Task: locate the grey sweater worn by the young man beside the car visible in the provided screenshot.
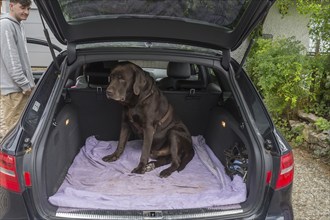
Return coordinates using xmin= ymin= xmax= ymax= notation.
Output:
xmin=0 ymin=15 xmax=35 ymax=95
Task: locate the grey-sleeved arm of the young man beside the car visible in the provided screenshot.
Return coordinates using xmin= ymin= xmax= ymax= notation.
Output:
xmin=1 ymin=22 xmax=31 ymax=91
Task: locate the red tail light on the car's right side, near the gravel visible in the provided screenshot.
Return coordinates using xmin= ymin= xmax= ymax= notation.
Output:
xmin=275 ymin=151 xmax=294 ymax=189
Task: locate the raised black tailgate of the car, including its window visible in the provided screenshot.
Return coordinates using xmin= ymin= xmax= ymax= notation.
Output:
xmin=35 ymin=0 xmax=275 ymax=50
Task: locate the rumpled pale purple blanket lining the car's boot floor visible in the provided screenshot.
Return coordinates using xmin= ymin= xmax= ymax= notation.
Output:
xmin=49 ymin=136 xmax=246 ymax=210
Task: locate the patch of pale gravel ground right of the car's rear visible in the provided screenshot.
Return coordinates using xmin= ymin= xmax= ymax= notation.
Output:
xmin=293 ymin=149 xmax=330 ymax=220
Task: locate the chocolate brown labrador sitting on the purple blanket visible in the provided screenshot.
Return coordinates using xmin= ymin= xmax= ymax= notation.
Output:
xmin=103 ymin=62 xmax=195 ymax=177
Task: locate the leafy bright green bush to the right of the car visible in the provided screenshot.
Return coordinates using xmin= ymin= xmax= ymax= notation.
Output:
xmin=246 ymin=38 xmax=313 ymax=121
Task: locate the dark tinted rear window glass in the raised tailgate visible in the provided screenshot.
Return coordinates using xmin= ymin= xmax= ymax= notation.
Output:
xmin=58 ymin=0 xmax=250 ymax=28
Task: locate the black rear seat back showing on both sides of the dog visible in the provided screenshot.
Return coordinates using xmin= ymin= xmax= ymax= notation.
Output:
xmin=65 ymin=85 xmax=221 ymax=140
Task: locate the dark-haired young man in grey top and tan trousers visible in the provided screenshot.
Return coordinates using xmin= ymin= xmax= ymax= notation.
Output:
xmin=0 ymin=0 xmax=35 ymax=138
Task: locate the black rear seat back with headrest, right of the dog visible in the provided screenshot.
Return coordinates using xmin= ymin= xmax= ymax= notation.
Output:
xmin=158 ymin=62 xmax=222 ymax=135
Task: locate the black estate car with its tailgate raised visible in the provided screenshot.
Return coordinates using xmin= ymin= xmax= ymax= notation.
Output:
xmin=0 ymin=0 xmax=294 ymax=219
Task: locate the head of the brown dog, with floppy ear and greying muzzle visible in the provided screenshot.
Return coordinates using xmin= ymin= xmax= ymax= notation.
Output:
xmin=106 ymin=62 xmax=147 ymax=102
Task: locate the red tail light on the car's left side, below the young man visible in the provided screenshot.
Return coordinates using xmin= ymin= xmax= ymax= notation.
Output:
xmin=0 ymin=152 xmax=20 ymax=192
